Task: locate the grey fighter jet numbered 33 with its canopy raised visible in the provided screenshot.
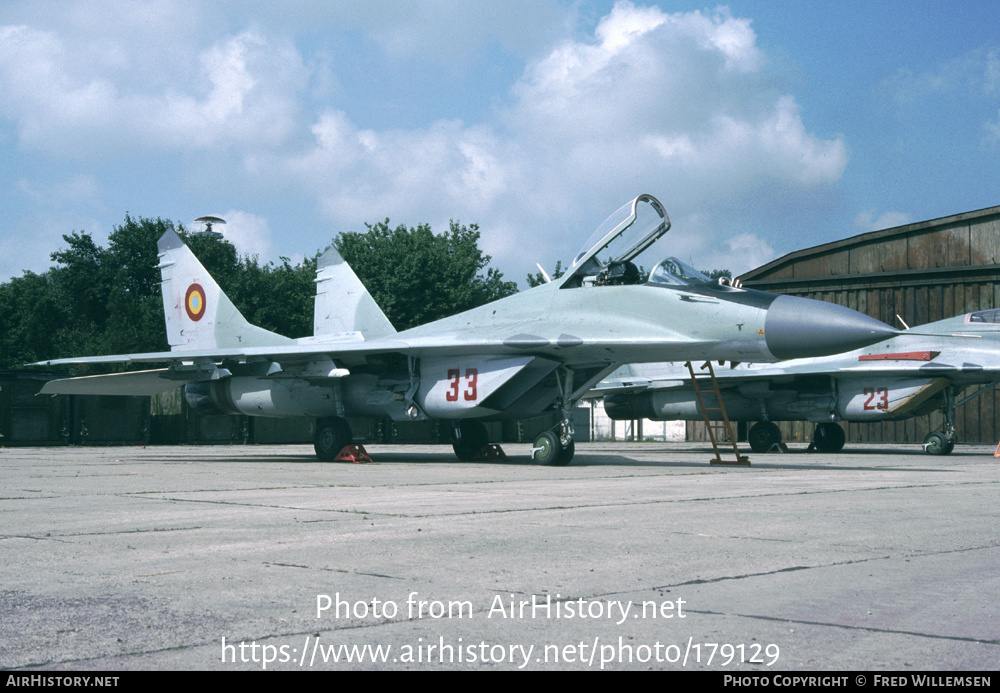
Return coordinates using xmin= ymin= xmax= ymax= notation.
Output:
xmin=35 ymin=195 xmax=897 ymax=465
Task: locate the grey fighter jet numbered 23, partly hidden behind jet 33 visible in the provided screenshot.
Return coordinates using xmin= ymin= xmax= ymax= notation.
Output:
xmin=591 ymin=310 xmax=1000 ymax=455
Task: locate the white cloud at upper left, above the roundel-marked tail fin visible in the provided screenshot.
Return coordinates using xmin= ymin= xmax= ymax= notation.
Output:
xmin=0 ymin=26 xmax=307 ymax=158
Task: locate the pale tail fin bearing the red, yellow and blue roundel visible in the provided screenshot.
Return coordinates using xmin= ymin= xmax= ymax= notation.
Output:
xmin=157 ymin=229 xmax=293 ymax=351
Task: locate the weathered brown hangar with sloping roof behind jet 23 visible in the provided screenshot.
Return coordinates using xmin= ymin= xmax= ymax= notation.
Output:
xmin=732 ymin=207 xmax=1000 ymax=444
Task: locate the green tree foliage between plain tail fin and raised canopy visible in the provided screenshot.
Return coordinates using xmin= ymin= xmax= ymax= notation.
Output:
xmin=334 ymin=219 xmax=517 ymax=330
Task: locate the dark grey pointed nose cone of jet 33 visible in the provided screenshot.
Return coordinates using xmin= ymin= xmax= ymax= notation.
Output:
xmin=764 ymin=295 xmax=899 ymax=359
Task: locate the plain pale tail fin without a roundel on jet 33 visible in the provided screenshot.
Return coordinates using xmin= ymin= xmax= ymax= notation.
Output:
xmin=313 ymin=246 xmax=396 ymax=339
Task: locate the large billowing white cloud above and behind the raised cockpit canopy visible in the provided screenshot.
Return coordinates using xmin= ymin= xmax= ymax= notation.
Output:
xmin=270 ymin=2 xmax=847 ymax=274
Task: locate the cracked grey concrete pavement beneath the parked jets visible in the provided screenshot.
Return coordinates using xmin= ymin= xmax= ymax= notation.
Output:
xmin=0 ymin=443 xmax=1000 ymax=672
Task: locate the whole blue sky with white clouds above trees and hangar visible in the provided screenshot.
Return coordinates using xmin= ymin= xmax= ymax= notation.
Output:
xmin=0 ymin=0 xmax=1000 ymax=283
